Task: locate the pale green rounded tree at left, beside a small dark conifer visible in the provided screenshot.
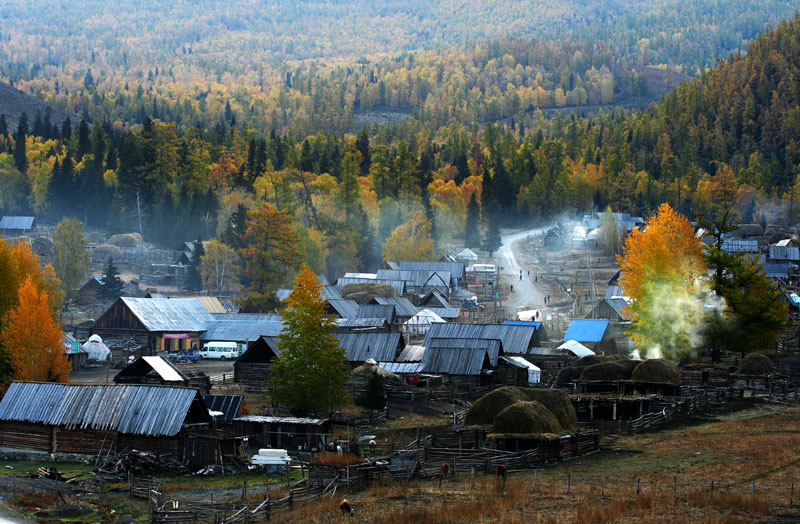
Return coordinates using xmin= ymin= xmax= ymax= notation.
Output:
xmin=53 ymin=218 xmax=92 ymax=298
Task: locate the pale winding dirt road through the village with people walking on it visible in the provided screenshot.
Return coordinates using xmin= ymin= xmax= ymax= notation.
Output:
xmin=495 ymin=228 xmax=546 ymax=315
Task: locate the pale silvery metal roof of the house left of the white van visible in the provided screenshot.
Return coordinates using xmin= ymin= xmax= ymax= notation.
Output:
xmin=120 ymin=297 xmax=213 ymax=332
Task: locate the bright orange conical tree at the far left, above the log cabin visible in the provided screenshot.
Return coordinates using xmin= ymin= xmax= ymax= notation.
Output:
xmin=2 ymin=277 xmax=70 ymax=382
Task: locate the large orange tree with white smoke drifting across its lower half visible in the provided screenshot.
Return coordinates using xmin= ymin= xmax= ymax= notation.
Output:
xmin=617 ymin=204 xmax=709 ymax=358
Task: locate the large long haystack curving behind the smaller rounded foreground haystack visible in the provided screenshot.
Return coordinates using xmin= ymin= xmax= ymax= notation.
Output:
xmin=464 ymin=386 xmax=578 ymax=433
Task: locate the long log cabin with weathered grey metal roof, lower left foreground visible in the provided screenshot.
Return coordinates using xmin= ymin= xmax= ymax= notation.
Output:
xmin=0 ymin=382 xmax=216 ymax=467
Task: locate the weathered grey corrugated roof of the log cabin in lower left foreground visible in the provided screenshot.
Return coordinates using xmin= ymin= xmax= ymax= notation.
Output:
xmin=0 ymin=382 xmax=210 ymax=436
